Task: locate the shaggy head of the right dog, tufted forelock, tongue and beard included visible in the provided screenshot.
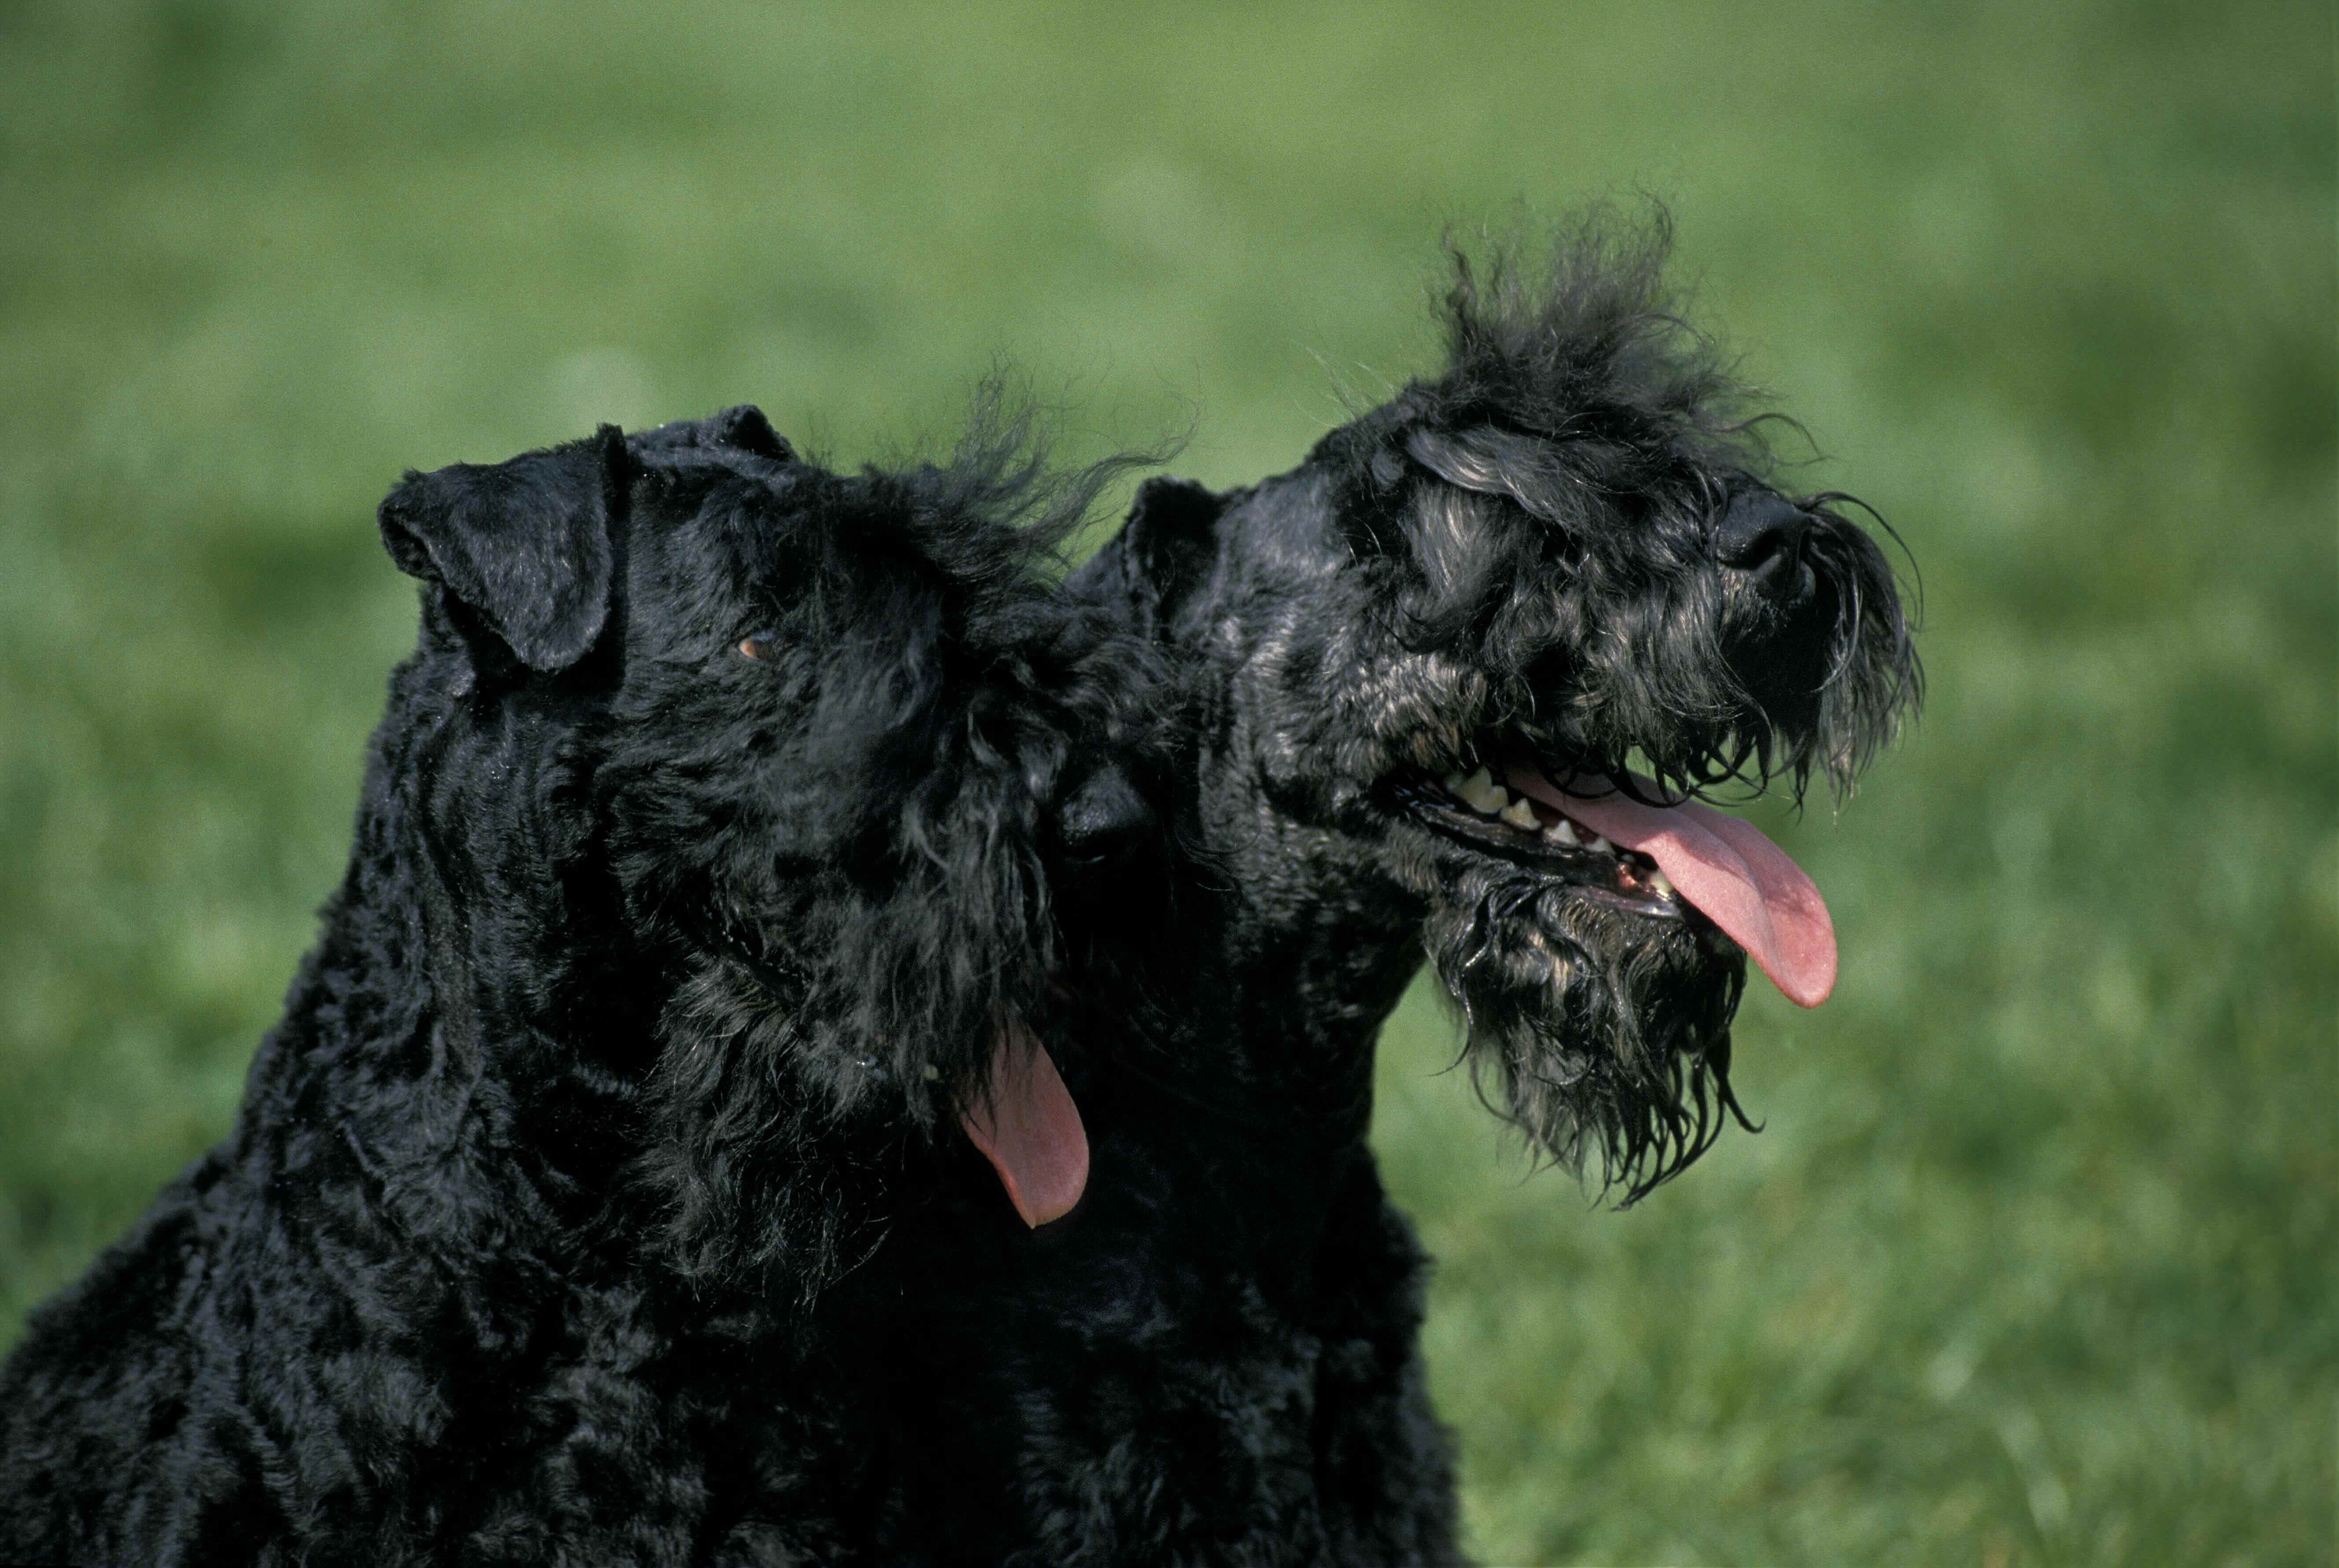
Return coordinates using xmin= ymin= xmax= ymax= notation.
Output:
xmin=1078 ymin=225 xmax=1920 ymax=1196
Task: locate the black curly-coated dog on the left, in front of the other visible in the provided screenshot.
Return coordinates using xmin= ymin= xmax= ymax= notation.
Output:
xmin=0 ymin=410 xmax=1170 ymax=1563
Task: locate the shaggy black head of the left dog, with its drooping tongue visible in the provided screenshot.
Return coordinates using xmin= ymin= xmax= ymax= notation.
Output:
xmin=381 ymin=410 xmax=1153 ymax=1280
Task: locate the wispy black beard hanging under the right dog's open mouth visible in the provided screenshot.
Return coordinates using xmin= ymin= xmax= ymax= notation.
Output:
xmin=1427 ymin=866 xmax=1747 ymax=1208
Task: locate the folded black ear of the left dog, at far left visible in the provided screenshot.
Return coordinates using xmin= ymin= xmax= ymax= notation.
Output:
xmin=381 ymin=426 xmax=627 ymax=672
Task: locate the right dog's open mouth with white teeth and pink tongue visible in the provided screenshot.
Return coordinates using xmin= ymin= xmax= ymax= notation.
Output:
xmin=1394 ymin=749 xmax=1836 ymax=1006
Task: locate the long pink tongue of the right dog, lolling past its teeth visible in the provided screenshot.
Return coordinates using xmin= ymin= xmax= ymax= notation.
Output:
xmin=1504 ymin=768 xmax=1836 ymax=1006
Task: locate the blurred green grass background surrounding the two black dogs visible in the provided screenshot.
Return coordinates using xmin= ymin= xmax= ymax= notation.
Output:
xmin=0 ymin=0 xmax=2339 ymax=1566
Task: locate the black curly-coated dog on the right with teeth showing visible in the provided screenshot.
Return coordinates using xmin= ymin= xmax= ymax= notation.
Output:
xmin=1024 ymin=222 xmax=1920 ymax=1563
